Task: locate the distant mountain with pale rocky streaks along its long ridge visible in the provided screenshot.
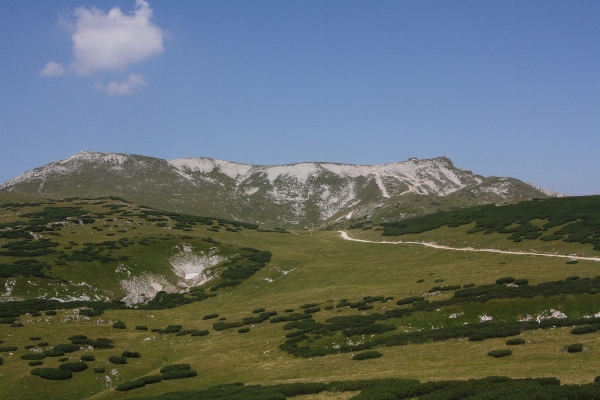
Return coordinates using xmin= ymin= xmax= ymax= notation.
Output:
xmin=0 ymin=151 xmax=552 ymax=228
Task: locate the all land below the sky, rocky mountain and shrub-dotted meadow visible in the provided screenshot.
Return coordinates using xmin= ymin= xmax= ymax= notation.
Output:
xmin=0 ymin=152 xmax=600 ymax=400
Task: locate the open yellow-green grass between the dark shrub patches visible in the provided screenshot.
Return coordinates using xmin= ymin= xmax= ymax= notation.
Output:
xmin=0 ymin=193 xmax=600 ymax=399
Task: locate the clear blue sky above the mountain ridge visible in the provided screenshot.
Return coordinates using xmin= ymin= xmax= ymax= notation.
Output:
xmin=0 ymin=0 xmax=600 ymax=195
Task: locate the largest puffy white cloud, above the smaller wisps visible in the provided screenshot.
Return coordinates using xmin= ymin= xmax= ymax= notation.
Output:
xmin=72 ymin=0 xmax=164 ymax=74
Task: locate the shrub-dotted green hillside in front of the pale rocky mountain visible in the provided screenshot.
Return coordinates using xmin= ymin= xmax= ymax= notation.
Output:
xmin=0 ymin=193 xmax=600 ymax=400
